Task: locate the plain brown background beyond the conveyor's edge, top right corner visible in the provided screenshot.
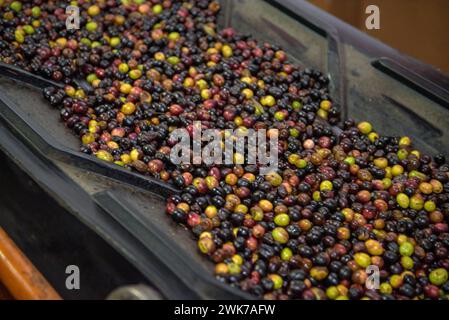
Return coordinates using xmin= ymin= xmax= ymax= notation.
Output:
xmin=308 ymin=0 xmax=449 ymax=74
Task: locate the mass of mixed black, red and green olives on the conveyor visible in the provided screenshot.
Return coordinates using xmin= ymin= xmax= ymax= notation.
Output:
xmin=5 ymin=0 xmax=449 ymax=300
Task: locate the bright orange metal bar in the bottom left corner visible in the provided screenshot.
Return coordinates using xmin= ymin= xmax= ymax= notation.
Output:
xmin=0 ymin=228 xmax=61 ymax=300
